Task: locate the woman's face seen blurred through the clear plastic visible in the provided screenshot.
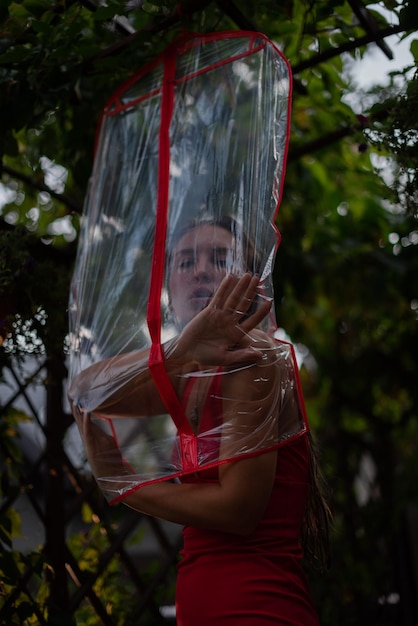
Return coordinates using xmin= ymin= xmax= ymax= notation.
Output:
xmin=168 ymin=225 xmax=237 ymax=326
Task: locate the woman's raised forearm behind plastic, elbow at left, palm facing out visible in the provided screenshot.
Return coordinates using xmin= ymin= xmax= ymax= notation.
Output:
xmin=68 ymin=274 xmax=271 ymax=417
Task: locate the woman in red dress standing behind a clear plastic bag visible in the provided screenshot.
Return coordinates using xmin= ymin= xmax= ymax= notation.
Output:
xmin=69 ymin=217 xmax=328 ymax=626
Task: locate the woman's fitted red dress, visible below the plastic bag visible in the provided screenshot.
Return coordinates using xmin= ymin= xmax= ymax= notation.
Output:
xmin=176 ymin=372 xmax=319 ymax=626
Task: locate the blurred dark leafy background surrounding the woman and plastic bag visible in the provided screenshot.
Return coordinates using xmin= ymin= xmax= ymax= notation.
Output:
xmin=0 ymin=0 xmax=418 ymax=626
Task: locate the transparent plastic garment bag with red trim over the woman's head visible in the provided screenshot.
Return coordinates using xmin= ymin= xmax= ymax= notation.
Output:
xmin=69 ymin=31 xmax=307 ymax=502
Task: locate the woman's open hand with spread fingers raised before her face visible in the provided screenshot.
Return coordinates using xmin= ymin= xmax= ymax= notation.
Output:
xmin=171 ymin=274 xmax=271 ymax=366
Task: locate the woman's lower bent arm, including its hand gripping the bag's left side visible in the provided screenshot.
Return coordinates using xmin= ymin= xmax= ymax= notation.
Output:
xmin=80 ymin=344 xmax=278 ymax=535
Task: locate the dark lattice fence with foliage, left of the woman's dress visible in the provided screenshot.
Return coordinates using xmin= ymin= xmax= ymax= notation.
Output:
xmin=0 ymin=356 xmax=181 ymax=626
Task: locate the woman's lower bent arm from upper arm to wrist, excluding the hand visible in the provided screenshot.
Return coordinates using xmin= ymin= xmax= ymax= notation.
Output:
xmin=124 ymin=354 xmax=280 ymax=535
